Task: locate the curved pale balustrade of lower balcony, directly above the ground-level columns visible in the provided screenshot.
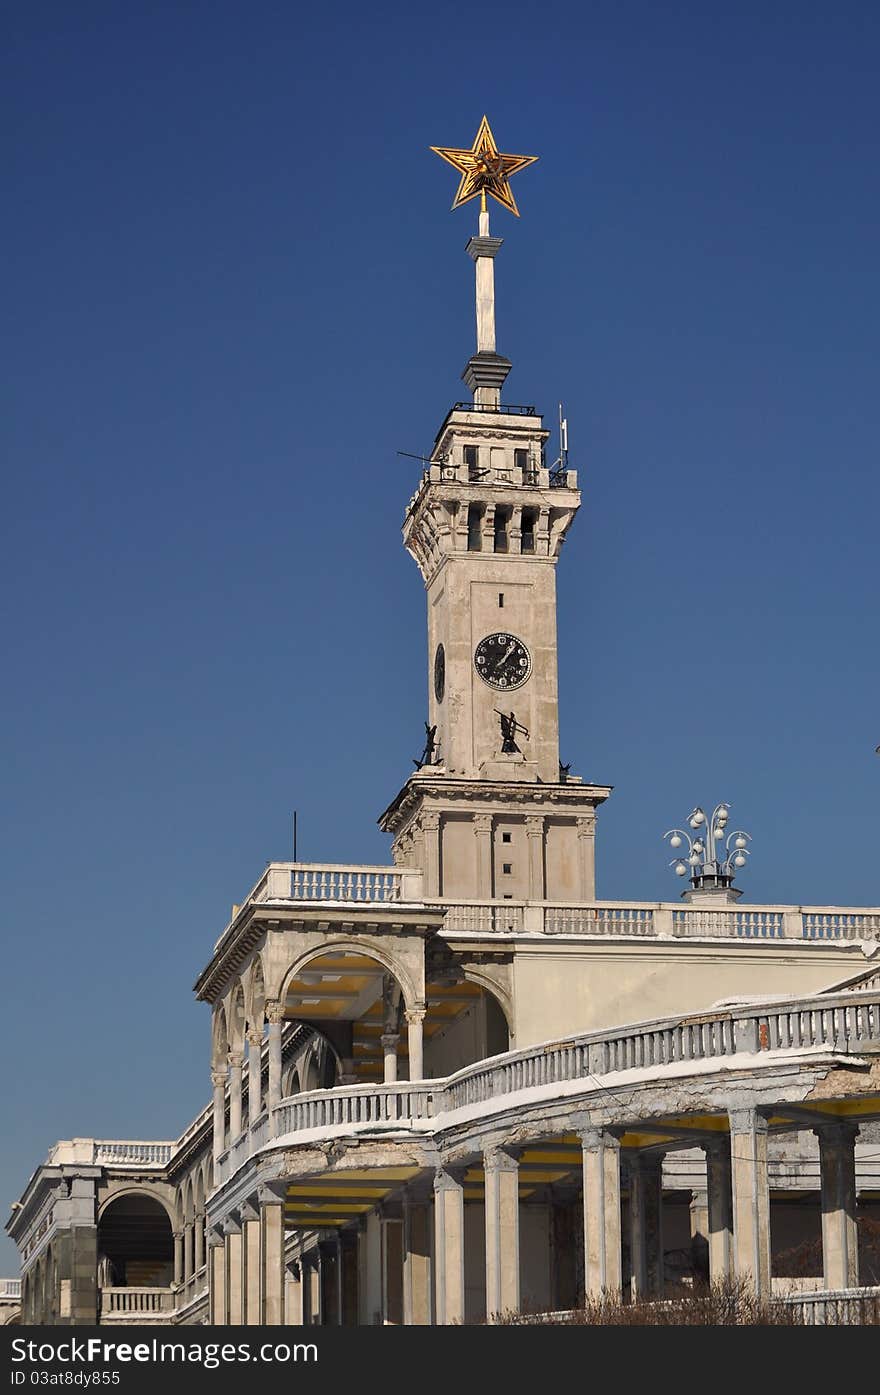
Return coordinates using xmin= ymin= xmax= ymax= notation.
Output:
xmin=218 ymin=992 xmax=880 ymax=1183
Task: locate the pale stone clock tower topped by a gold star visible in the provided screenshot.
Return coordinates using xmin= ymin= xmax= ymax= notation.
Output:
xmin=379 ymin=117 xmax=609 ymax=910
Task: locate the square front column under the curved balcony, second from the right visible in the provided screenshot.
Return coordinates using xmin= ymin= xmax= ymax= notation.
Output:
xmin=729 ymin=1109 xmax=770 ymax=1297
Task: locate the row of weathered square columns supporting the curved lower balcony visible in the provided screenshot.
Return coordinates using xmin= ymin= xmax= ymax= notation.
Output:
xmin=209 ymin=1108 xmax=858 ymax=1325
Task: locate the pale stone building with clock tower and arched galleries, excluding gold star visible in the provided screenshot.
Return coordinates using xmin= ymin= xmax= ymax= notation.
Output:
xmin=7 ymin=133 xmax=880 ymax=1324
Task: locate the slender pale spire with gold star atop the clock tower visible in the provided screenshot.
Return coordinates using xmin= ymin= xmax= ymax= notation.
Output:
xmin=431 ymin=116 xmax=537 ymax=409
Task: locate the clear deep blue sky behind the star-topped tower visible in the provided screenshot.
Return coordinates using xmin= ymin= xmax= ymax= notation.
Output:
xmin=0 ymin=0 xmax=880 ymax=1272
